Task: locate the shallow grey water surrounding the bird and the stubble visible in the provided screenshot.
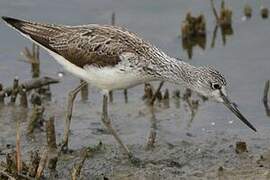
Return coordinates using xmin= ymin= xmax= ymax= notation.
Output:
xmin=0 ymin=0 xmax=270 ymax=177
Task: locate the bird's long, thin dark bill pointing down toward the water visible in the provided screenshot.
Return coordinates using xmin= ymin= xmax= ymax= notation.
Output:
xmin=220 ymin=91 xmax=257 ymax=132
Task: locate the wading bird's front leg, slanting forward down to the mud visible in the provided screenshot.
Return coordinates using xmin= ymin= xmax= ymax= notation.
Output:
xmin=101 ymin=94 xmax=132 ymax=158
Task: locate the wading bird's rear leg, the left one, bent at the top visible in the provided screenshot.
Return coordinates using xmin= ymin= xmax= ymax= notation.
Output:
xmin=61 ymin=81 xmax=87 ymax=152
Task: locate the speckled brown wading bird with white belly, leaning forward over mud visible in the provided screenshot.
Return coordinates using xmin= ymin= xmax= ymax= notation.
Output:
xmin=2 ymin=17 xmax=256 ymax=157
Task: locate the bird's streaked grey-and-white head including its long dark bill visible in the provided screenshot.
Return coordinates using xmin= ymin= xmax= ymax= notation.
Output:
xmin=192 ymin=66 xmax=256 ymax=131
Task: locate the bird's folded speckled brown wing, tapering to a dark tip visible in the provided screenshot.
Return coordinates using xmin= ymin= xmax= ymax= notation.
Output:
xmin=3 ymin=17 xmax=147 ymax=67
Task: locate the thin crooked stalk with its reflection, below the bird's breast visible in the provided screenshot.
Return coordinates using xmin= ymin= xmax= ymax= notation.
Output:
xmin=146 ymin=81 xmax=164 ymax=150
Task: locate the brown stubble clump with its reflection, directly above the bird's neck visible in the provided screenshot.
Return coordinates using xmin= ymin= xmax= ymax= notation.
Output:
xmin=181 ymin=12 xmax=206 ymax=59
